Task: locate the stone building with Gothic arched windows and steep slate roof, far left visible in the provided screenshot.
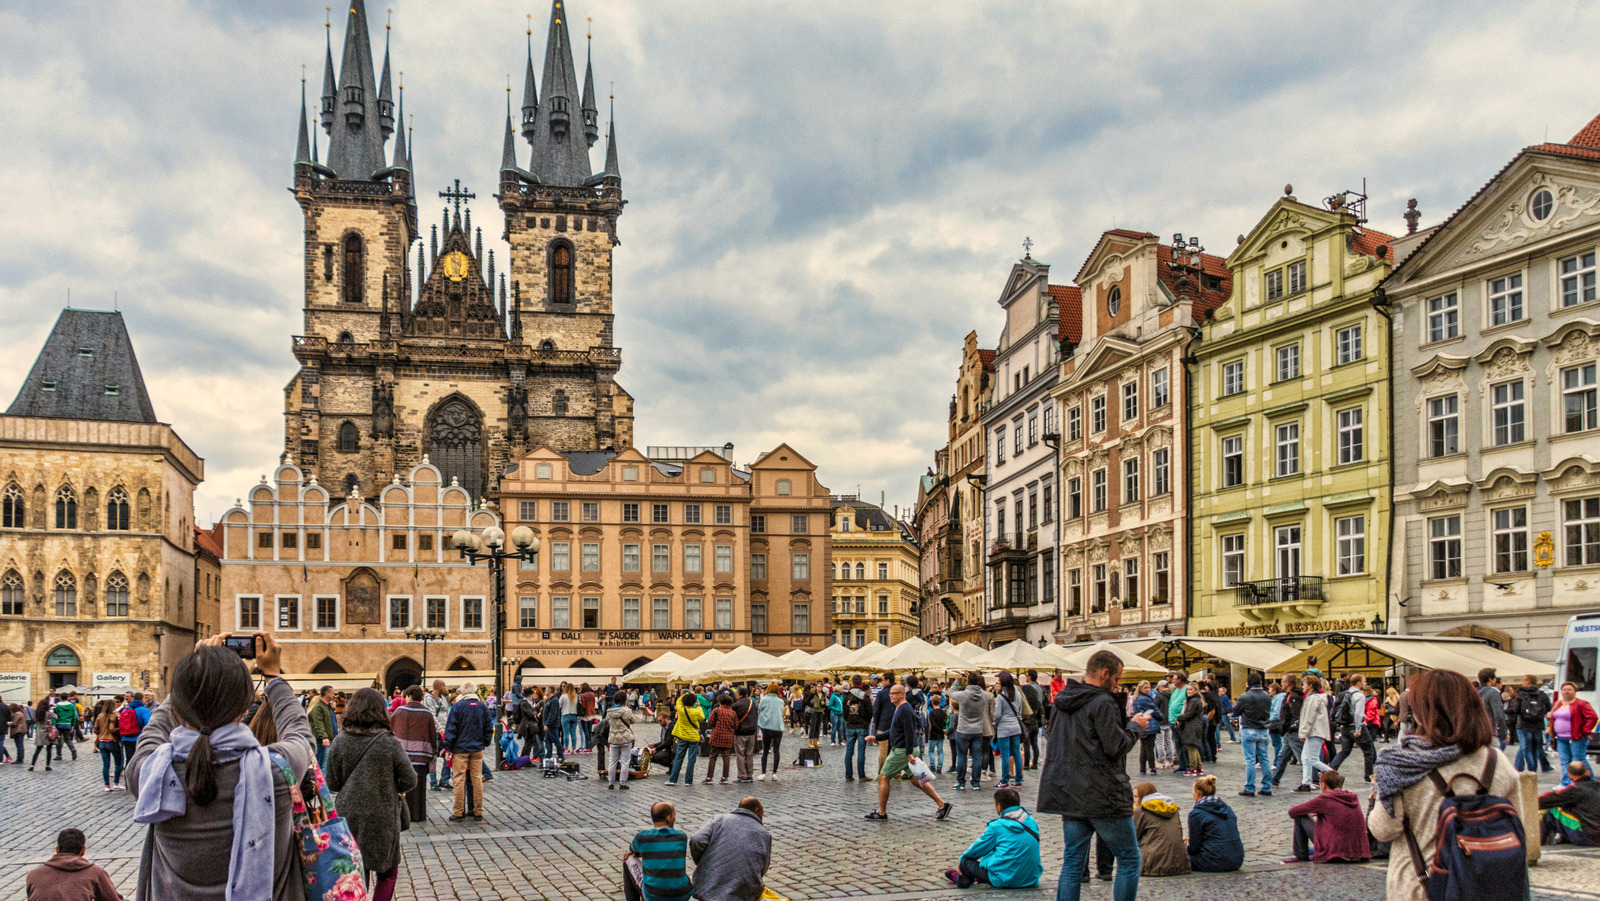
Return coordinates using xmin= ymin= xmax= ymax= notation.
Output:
xmin=0 ymin=309 xmax=206 ymax=703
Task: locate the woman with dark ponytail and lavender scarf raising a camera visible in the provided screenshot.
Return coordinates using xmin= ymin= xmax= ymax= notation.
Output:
xmin=128 ymin=632 xmax=314 ymax=901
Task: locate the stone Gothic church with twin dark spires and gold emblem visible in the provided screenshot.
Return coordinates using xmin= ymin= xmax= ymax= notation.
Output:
xmin=285 ymin=0 xmax=634 ymax=499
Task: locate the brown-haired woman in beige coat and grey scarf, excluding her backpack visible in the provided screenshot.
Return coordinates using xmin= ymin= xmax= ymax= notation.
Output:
xmin=1366 ymin=669 xmax=1522 ymax=901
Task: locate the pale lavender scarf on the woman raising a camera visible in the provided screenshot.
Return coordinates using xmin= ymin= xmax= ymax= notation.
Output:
xmin=133 ymin=723 xmax=277 ymax=901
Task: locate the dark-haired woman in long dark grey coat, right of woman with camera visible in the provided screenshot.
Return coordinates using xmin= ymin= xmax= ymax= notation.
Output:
xmin=328 ymin=688 xmax=416 ymax=901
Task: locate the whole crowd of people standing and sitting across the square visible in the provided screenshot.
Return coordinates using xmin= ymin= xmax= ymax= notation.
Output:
xmin=6 ymin=634 xmax=1600 ymax=901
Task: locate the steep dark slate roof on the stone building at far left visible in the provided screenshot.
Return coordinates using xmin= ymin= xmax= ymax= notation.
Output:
xmin=6 ymin=309 xmax=157 ymax=422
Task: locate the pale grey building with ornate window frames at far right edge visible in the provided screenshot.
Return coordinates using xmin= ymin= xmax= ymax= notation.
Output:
xmin=1384 ymin=118 xmax=1600 ymax=659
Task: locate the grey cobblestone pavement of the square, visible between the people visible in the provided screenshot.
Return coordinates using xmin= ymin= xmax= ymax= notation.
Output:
xmin=0 ymin=735 xmax=1600 ymax=901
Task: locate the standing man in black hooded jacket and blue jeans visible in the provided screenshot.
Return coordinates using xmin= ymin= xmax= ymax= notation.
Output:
xmin=1037 ymin=650 xmax=1150 ymax=901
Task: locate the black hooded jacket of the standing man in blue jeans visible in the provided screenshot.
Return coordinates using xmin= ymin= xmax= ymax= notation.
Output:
xmin=1037 ymin=682 xmax=1144 ymax=819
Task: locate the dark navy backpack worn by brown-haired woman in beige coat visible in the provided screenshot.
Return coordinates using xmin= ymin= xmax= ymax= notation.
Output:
xmin=1405 ymin=749 xmax=1528 ymax=901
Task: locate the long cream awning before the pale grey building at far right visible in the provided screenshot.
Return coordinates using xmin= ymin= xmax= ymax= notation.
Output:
xmin=1272 ymin=632 xmax=1555 ymax=679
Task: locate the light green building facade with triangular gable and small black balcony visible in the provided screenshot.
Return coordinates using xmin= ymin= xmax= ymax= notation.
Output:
xmin=1187 ymin=194 xmax=1394 ymax=639
